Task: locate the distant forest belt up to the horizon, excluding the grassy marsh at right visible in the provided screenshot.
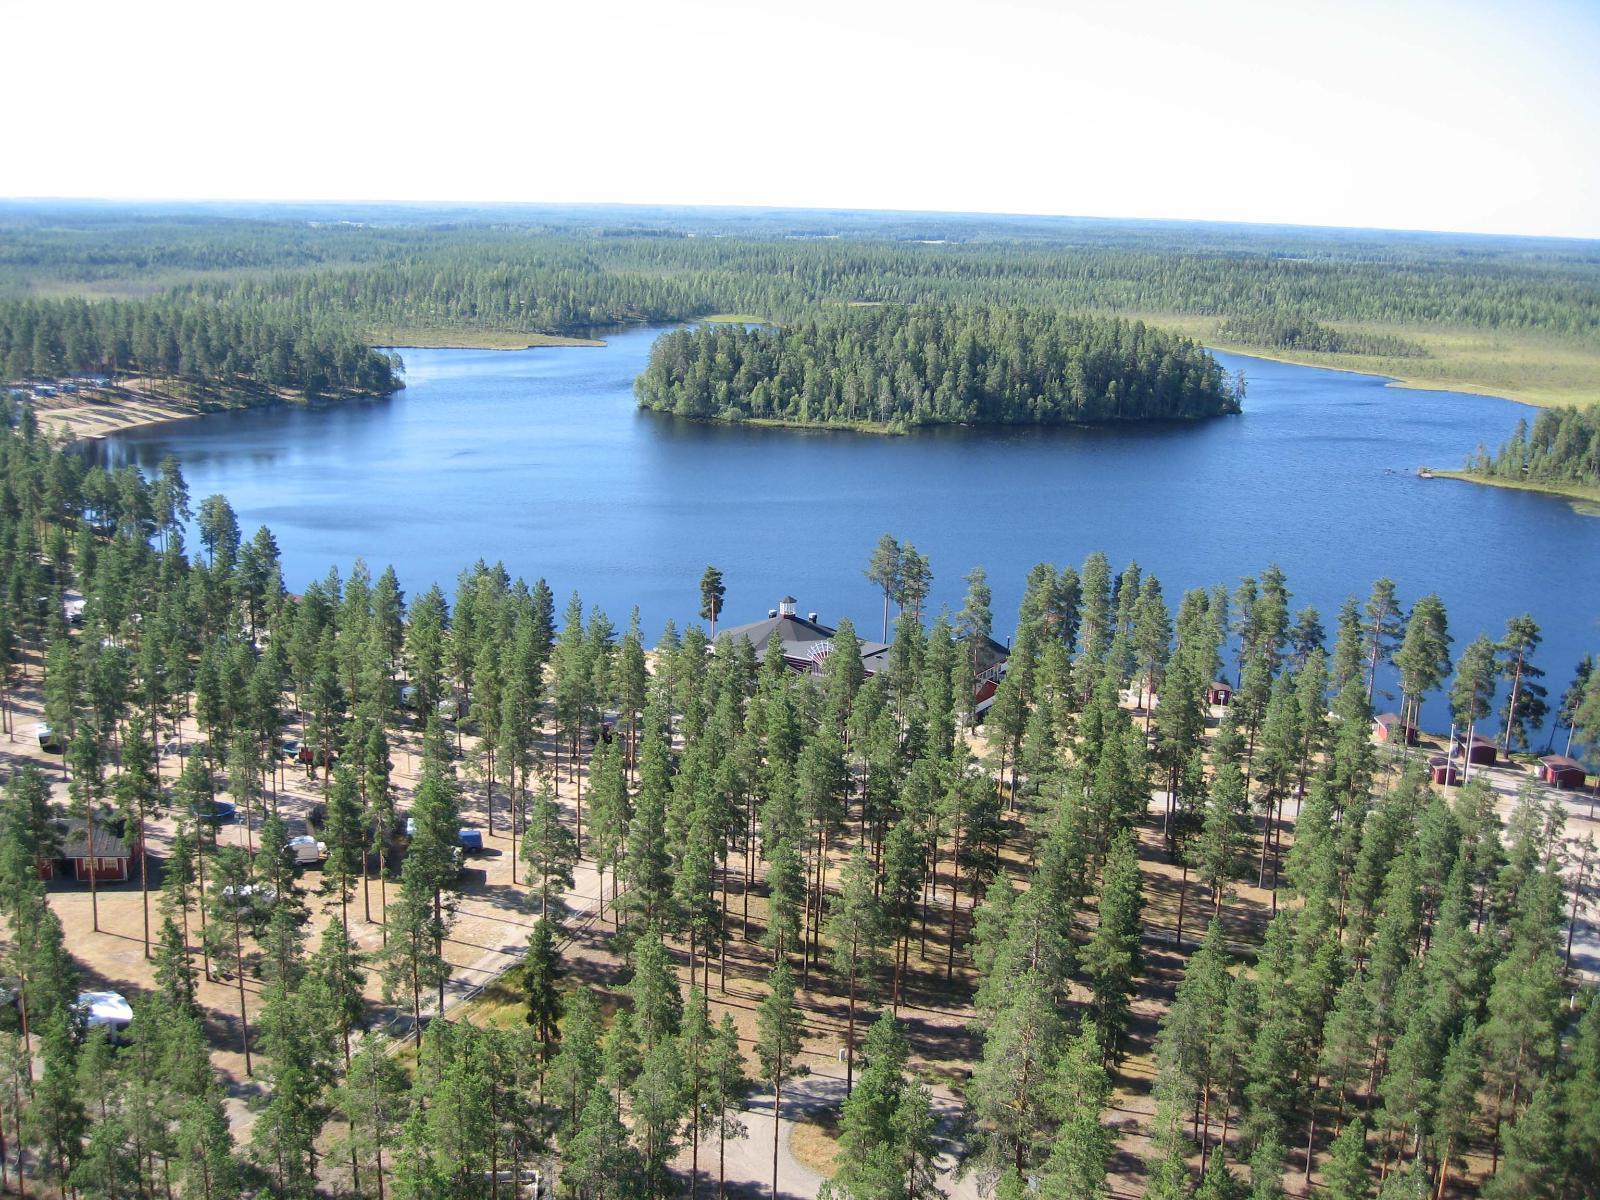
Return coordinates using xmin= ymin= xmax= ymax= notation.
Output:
xmin=12 ymin=210 xmax=1600 ymax=336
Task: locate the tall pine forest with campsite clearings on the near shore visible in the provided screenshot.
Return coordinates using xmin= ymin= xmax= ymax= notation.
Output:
xmin=0 ymin=390 xmax=1600 ymax=1200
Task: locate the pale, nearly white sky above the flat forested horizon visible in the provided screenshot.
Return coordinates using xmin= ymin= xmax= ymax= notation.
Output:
xmin=0 ymin=0 xmax=1600 ymax=237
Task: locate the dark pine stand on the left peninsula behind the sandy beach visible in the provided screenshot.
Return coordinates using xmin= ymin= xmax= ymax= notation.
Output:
xmin=0 ymin=299 xmax=400 ymax=397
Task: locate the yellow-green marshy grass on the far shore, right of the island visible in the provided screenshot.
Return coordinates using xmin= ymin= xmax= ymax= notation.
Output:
xmin=1122 ymin=312 xmax=1600 ymax=408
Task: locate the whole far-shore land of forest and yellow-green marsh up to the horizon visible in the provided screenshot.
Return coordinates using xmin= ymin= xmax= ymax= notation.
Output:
xmin=9 ymin=203 xmax=1600 ymax=403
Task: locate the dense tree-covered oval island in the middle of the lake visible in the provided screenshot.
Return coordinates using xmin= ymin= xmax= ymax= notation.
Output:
xmin=634 ymin=306 xmax=1238 ymax=429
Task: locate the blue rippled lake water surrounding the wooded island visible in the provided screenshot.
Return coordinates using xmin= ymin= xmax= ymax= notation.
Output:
xmin=98 ymin=330 xmax=1600 ymax=739
